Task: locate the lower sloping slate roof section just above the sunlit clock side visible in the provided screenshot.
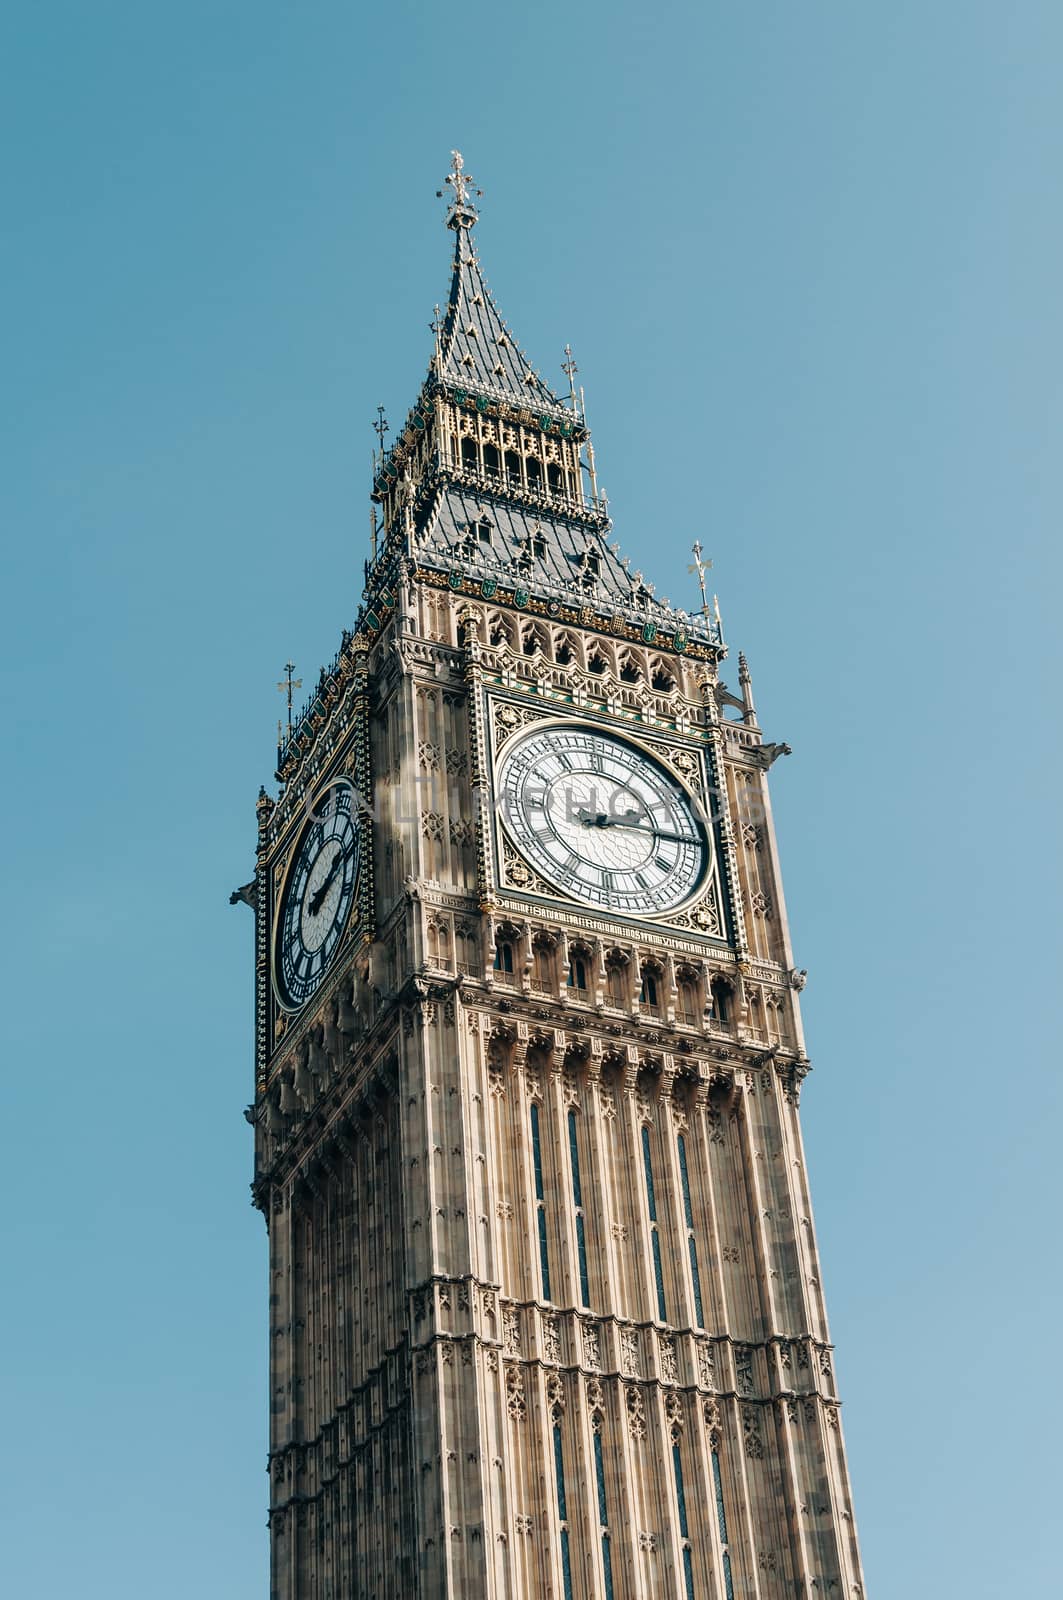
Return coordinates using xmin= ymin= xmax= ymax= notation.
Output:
xmin=413 ymin=483 xmax=685 ymax=632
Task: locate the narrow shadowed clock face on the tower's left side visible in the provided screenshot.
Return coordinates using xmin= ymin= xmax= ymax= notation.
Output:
xmin=274 ymin=781 xmax=359 ymax=1011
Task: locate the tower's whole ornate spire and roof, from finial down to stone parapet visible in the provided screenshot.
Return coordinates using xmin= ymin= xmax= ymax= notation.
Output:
xmin=359 ymin=150 xmax=719 ymax=651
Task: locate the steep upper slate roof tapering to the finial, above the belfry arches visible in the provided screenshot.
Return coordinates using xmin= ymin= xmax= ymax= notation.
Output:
xmin=439 ymin=227 xmax=568 ymax=414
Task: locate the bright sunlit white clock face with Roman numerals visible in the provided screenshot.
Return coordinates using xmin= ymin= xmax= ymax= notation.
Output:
xmin=498 ymin=725 xmax=709 ymax=917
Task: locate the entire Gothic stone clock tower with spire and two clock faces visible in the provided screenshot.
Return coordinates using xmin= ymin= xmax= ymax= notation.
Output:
xmin=249 ymin=157 xmax=863 ymax=1600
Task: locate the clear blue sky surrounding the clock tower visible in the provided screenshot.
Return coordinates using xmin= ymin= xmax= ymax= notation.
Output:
xmin=0 ymin=0 xmax=1063 ymax=1600
